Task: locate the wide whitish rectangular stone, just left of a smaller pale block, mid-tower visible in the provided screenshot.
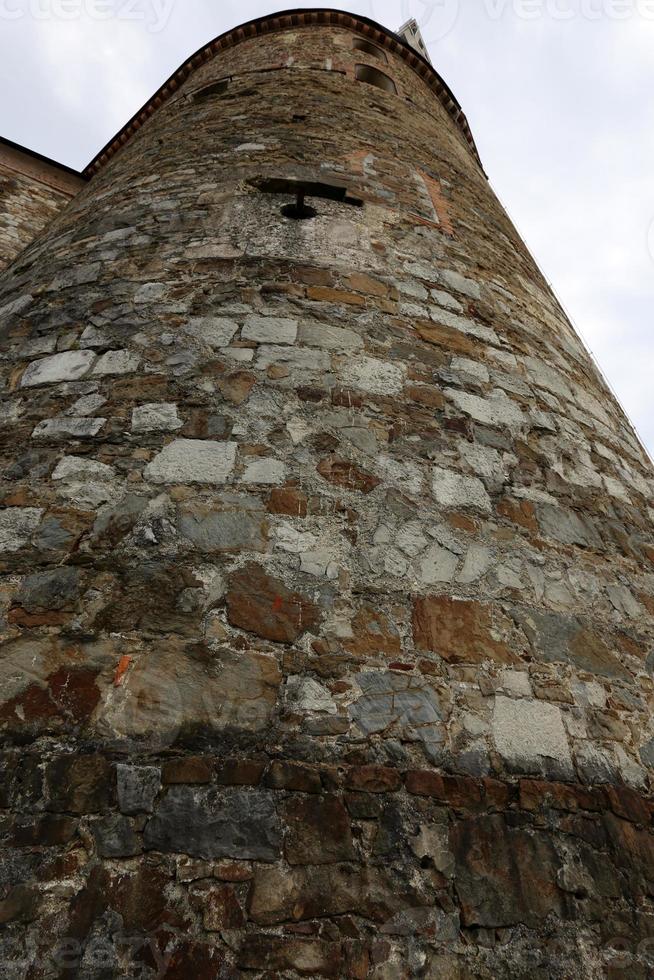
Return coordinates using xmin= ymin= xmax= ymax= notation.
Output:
xmin=145 ymin=439 xmax=236 ymax=484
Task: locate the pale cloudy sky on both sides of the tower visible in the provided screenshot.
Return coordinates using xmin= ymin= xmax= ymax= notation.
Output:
xmin=0 ymin=0 xmax=654 ymax=455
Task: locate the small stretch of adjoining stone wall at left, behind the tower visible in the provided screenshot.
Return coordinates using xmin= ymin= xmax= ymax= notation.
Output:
xmin=0 ymin=140 xmax=84 ymax=269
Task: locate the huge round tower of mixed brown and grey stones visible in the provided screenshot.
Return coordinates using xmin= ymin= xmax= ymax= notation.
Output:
xmin=0 ymin=10 xmax=654 ymax=980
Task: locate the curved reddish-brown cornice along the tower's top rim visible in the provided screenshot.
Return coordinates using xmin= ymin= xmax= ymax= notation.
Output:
xmin=83 ymin=8 xmax=483 ymax=179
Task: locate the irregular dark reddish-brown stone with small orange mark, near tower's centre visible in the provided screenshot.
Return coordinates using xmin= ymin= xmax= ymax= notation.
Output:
xmin=227 ymin=564 xmax=321 ymax=643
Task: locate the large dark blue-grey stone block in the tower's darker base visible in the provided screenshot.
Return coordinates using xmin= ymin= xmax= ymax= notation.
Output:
xmin=144 ymin=786 xmax=282 ymax=861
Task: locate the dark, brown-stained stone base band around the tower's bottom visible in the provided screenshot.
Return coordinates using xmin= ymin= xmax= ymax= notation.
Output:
xmin=0 ymin=752 xmax=654 ymax=980
